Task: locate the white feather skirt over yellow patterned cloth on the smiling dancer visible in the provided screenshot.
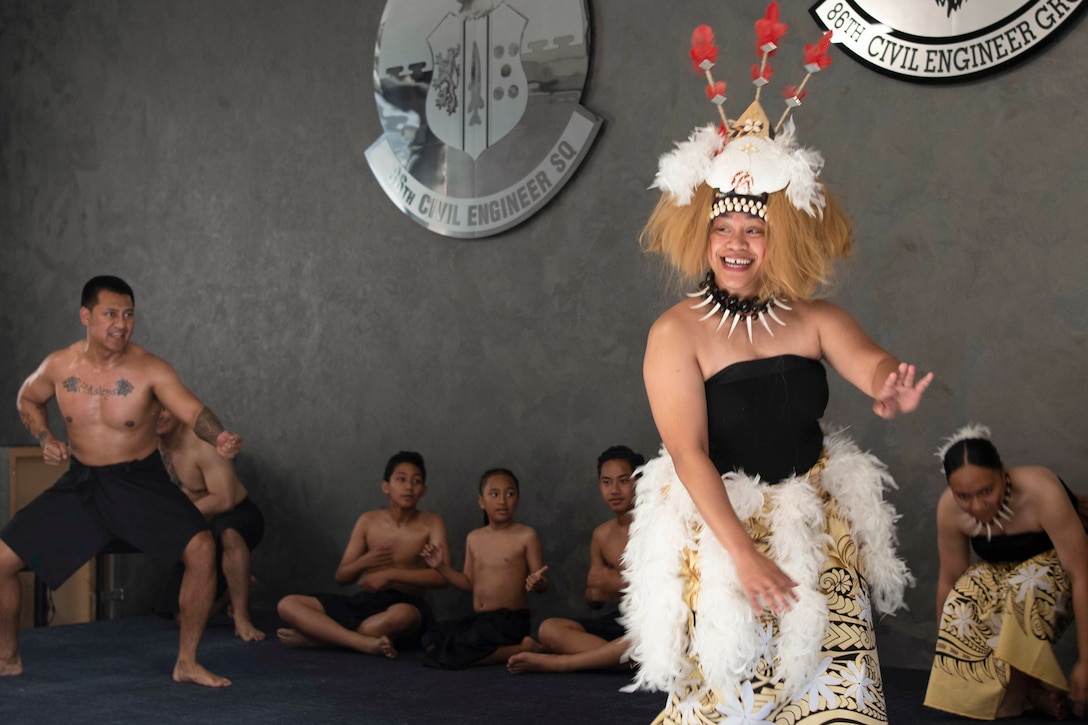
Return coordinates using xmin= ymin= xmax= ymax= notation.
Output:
xmin=620 ymin=431 xmax=914 ymax=723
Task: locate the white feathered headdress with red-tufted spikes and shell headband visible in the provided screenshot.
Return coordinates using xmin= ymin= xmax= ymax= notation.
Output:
xmin=652 ymin=2 xmax=831 ymax=219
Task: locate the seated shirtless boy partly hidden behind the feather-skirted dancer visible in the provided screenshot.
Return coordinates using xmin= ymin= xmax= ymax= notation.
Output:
xmin=506 ymin=445 xmax=645 ymax=675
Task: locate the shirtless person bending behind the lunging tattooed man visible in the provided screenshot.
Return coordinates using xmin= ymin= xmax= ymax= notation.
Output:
xmin=156 ymin=409 xmax=264 ymax=642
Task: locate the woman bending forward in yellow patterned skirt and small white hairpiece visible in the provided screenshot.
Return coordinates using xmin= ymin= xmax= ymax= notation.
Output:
xmin=926 ymin=425 xmax=1088 ymax=720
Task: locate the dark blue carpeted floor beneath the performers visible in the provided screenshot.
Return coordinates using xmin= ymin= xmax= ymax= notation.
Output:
xmin=0 ymin=614 xmax=1070 ymax=725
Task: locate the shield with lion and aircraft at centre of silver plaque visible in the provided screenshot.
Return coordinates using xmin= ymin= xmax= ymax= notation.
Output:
xmin=426 ymin=3 xmax=529 ymax=160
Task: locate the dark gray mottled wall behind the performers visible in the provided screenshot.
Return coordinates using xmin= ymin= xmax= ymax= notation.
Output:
xmin=0 ymin=0 xmax=1088 ymax=666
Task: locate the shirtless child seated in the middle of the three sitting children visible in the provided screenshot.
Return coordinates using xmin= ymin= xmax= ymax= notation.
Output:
xmin=423 ymin=468 xmax=547 ymax=669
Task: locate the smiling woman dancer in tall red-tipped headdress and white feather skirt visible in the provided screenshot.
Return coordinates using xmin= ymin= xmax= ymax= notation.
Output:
xmin=622 ymin=3 xmax=932 ymax=724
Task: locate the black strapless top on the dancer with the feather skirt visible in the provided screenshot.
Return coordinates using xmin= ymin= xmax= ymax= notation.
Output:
xmin=704 ymin=355 xmax=828 ymax=483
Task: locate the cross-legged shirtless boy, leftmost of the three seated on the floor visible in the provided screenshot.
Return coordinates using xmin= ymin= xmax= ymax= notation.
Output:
xmin=276 ymin=451 xmax=446 ymax=659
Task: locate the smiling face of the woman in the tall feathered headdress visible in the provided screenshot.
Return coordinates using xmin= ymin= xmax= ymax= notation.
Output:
xmin=706 ymin=211 xmax=767 ymax=297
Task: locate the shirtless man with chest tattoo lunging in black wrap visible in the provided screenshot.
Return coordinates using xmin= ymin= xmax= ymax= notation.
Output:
xmin=0 ymin=277 xmax=242 ymax=687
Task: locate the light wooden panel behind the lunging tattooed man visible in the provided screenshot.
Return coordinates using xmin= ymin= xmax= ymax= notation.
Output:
xmin=8 ymin=446 xmax=95 ymax=628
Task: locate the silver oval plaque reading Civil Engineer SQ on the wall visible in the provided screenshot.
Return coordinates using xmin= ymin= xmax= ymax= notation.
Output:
xmin=367 ymin=0 xmax=601 ymax=238
